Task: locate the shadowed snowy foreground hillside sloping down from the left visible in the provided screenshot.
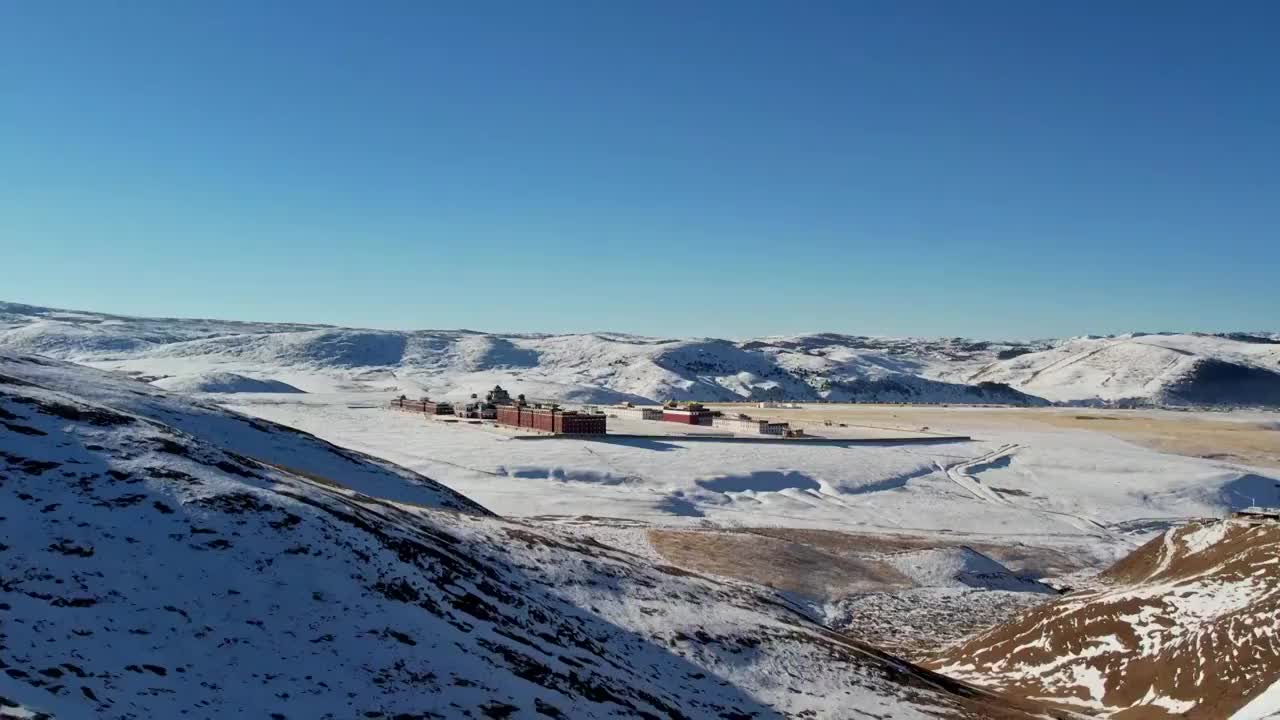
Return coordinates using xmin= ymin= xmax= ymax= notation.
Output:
xmin=0 ymin=354 xmax=1062 ymax=719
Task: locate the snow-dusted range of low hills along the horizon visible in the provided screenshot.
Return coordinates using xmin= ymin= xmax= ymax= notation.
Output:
xmin=0 ymin=302 xmax=1280 ymax=407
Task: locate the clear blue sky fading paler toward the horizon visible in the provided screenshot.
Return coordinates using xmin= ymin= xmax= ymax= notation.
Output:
xmin=0 ymin=0 xmax=1280 ymax=337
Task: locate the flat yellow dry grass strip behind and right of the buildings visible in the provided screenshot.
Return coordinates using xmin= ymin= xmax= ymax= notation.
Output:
xmin=710 ymin=404 xmax=1280 ymax=468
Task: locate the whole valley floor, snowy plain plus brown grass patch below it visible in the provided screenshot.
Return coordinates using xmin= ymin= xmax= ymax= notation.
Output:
xmin=223 ymin=393 xmax=1280 ymax=657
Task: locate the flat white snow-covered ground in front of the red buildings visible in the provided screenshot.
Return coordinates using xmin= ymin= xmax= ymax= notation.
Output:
xmin=224 ymin=393 xmax=1277 ymax=579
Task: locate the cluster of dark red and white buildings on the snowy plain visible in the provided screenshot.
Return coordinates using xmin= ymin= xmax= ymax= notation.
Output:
xmin=392 ymin=386 xmax=804 ymax=437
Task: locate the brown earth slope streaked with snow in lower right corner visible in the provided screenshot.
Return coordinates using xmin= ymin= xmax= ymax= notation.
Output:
xmin=929 ymin=521 xmax=1280 ymax=720
